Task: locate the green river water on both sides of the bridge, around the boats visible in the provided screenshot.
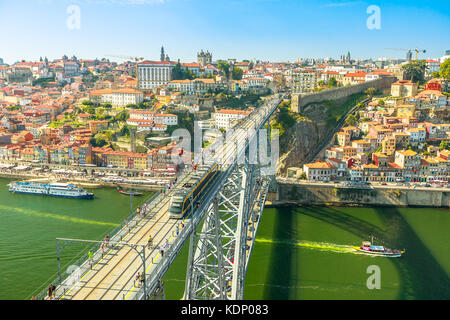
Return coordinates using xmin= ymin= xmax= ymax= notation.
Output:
xmin=0 ymin=179 xmax=450 ymax=299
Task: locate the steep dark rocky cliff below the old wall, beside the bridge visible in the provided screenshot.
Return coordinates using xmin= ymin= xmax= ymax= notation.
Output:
xmin=277 ymin=104 xmax=329 ymax=175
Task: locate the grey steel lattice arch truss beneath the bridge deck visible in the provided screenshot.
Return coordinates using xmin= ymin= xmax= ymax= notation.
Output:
xmin=184 ymin=125 xmax=271 ymax=300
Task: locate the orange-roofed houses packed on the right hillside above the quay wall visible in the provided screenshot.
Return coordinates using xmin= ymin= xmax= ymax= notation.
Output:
xmin=303 ymin=79 xmax=450 ymax=182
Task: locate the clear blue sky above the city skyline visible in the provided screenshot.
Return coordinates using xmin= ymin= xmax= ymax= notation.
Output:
xmin=0 ymin=0 xmax=450 ymax=63
